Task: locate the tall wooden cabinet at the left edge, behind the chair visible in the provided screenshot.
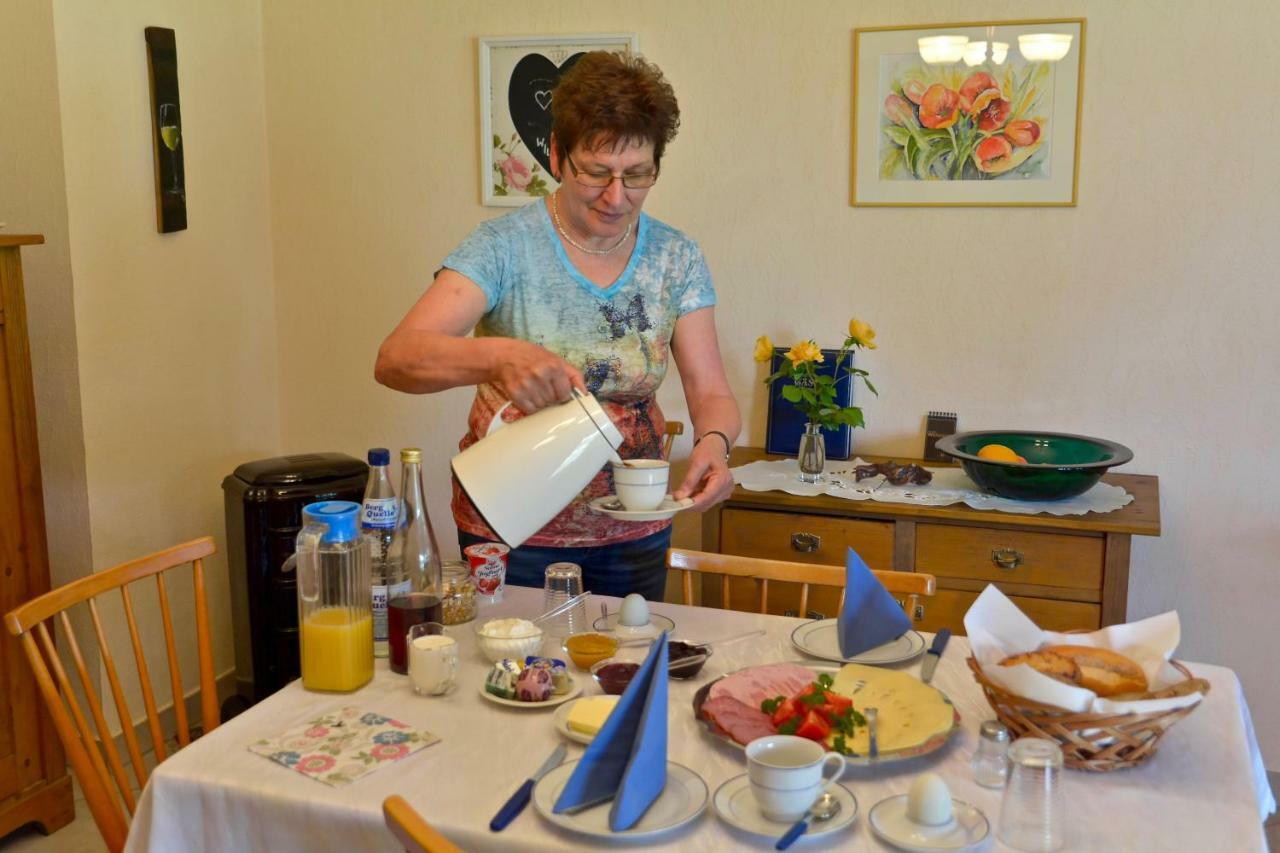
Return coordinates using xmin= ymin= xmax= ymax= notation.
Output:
xmin=0 ymin=234 xmax=74 ymax=836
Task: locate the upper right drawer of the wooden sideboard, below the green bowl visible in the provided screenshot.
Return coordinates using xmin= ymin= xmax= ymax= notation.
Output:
xmin=915 ymin=524 xmax=1106 ymax=590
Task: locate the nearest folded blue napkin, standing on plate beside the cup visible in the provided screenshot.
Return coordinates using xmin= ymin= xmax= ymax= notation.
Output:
xmin=552 ymin=631 xmax=667 ymax=833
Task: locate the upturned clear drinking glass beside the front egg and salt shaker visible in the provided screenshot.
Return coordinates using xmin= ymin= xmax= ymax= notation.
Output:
xmin=997 ymin=738 xmax=1066 ymax=853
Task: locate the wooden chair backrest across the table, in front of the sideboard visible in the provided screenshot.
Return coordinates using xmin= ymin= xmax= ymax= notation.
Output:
xmin=667 ymin=548 xmax=937 ymax=620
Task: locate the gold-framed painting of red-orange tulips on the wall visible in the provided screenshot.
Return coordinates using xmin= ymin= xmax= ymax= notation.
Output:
xmin=850 ymin=18 xmax=1087 ymax=207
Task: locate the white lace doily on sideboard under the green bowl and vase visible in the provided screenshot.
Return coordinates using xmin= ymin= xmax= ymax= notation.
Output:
xmin=730 ymin=459 xmax=1133 ymax=515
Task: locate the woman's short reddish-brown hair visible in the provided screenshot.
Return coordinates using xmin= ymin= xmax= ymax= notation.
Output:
xmin=552 ymin=50 xmax=680 ymax=165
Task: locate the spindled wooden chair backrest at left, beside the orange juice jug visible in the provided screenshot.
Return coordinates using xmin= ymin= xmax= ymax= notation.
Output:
xmin=5 ymin=537 xmax=219 ymax=852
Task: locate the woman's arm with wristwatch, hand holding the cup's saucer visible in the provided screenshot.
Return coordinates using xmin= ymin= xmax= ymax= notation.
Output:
xmin=671 ymin=307 xmax=742 ymax=511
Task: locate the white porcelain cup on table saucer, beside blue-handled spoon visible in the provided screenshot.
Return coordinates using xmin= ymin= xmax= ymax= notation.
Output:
xmin=746 ymin=735 xmax=845 ymax=824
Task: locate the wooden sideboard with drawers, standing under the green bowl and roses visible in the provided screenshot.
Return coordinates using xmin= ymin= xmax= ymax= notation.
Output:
xmin=703 ymin=447 xmax=1160 ymax=634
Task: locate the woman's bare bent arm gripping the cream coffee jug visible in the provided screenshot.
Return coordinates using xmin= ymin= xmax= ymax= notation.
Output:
xmin=374 ymin=269 xmax=585 ymax=414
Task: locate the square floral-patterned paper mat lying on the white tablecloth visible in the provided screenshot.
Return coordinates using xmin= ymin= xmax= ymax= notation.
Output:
xmin=248 ymin=707 xmax=439 ymax=786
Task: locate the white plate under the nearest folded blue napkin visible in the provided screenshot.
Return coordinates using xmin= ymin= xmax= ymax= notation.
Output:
xmin=534 ymin=761 xmax=710 ymax=841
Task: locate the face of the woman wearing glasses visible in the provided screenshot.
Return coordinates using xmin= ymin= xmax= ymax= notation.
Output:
xmin=552 ymin=136 xmax=658 ymax=240
